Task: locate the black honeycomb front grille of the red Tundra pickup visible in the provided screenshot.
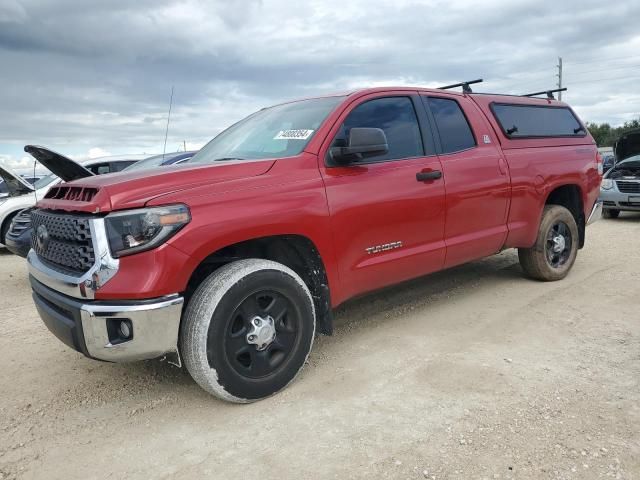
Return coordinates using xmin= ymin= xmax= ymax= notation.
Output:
xmin=31 ymin=210 xmax=95 ymax=274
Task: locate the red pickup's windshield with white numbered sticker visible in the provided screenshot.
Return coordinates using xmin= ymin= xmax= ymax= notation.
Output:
xmin=189 ymin=97 xmax=344 ymax=163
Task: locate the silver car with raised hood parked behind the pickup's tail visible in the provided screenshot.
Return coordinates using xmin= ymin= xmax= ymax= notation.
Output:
xmin=600 ymin=130 xmax=640 ymax=218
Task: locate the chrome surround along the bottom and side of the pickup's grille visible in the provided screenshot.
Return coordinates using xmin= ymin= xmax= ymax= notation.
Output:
xmin=27 ymin=218 xmax=120 ymax=300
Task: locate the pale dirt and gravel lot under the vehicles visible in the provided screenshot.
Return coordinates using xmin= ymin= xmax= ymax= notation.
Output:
xmin=0 ymin=214 xmax=640 ymax=480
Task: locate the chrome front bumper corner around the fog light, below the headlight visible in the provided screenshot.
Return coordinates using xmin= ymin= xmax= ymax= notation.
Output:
xmin=80 ymin=294 xmax=184 ymax=362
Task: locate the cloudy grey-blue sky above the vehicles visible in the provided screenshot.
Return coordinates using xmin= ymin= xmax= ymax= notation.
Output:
xmin=0 ymin=0 xmax=640 ymax=172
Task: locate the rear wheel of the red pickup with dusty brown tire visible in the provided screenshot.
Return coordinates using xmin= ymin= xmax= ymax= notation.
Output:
xmin=518 ymin=205 xmax=579 ymax=282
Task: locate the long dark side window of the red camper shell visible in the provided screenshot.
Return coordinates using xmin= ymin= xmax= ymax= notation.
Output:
xmin=491 ymin=103 xmax=586 ymax=138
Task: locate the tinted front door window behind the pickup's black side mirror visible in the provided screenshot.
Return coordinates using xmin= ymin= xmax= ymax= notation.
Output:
xmin=333 ymin=97 xmax=424 ymax=162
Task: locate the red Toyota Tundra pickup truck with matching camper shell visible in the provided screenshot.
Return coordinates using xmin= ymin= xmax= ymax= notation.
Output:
xmin=25 ymin=88 xmax=602 ymax=402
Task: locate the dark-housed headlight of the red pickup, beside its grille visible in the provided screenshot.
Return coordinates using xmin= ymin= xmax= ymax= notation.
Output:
xmin=104 ymin=205 xmax=191 ymax=258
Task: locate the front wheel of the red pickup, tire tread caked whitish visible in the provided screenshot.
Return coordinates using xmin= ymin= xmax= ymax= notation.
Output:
xmin=180 ymin=259 xmax=316 ymax=403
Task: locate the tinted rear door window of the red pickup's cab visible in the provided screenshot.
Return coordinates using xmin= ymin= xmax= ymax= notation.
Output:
xmin=428 ymin=97 xmax=476 ymax=153
